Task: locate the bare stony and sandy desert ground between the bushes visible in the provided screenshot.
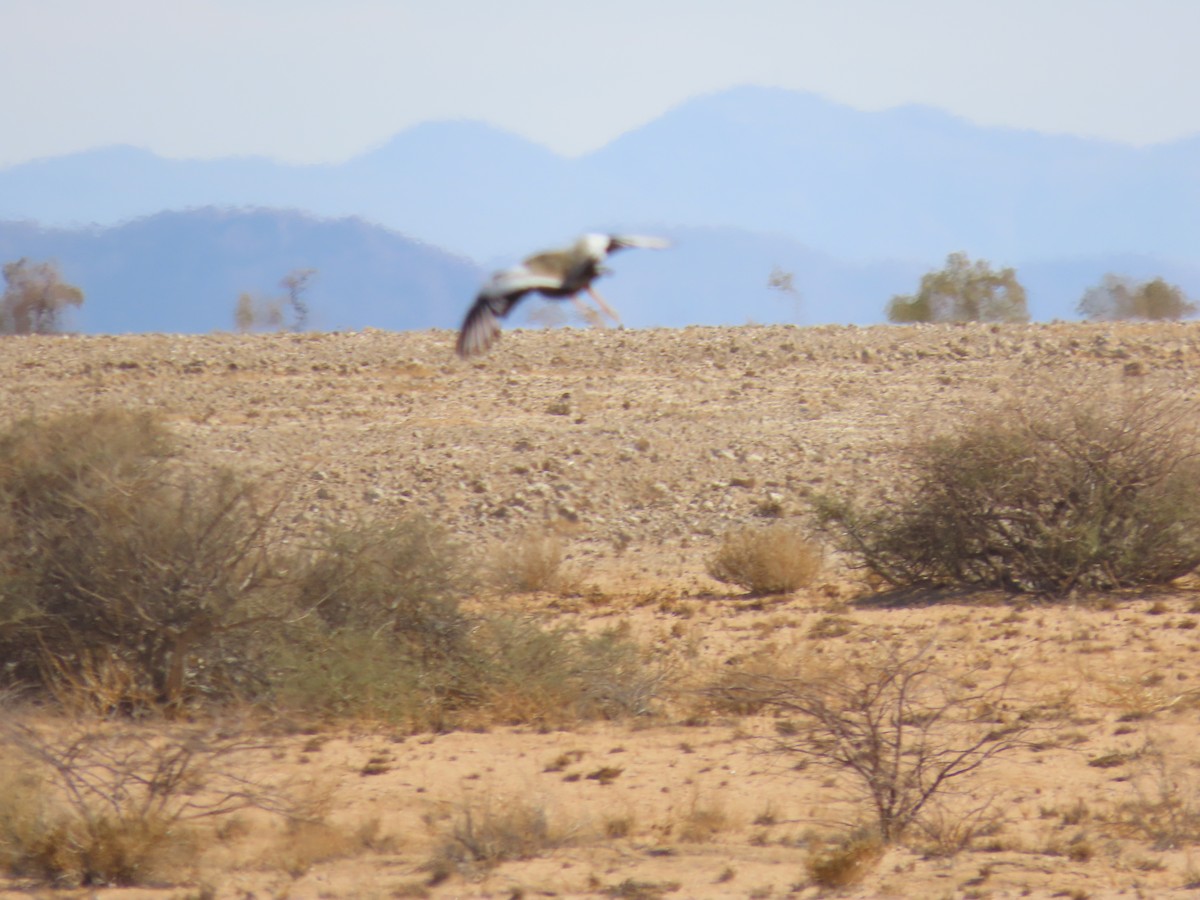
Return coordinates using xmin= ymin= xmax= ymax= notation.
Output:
xmin=0 ymin=323 xmax=1200 ymax=900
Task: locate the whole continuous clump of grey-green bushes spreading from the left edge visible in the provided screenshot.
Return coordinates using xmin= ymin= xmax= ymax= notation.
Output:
xmin=0 ymin=410 xmax=660 ymax=728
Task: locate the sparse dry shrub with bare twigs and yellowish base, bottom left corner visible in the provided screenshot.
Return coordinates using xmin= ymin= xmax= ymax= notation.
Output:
xmin=0 ymin=710 xmax=293 ymax=884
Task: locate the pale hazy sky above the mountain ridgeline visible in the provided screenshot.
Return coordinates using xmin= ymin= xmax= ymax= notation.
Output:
xmin=0 ymin=0 xmax=1200 ymax=166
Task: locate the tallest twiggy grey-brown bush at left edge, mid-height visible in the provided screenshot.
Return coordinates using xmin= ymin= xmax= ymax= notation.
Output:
xmin=0 ymin=409 xmax=280 ymax=713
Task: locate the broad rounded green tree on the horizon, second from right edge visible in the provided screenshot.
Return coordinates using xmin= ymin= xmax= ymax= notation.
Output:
xmin=887 ymin=253 xmax=1030 ymax=322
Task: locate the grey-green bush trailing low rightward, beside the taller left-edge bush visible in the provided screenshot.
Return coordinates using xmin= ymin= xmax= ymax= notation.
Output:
xmin=274 ymin=535 xmax=662 ymax=730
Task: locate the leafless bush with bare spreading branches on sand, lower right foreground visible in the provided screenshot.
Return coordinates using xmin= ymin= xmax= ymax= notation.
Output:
xmin=722 ymin=643 xmax=1031 ymax=842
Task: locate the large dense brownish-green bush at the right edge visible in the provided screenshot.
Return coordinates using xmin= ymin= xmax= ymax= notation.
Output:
xmin=817 ymin=386 xmax=1200 ymax=595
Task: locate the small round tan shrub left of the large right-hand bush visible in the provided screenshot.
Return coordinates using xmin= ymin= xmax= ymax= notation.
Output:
xmin=706 ymin=522 xmax=821 ymax=595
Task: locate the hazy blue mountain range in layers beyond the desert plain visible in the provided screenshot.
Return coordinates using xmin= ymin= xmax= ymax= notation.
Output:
xmin=0 ymin=88 xmax=1200 ymax=331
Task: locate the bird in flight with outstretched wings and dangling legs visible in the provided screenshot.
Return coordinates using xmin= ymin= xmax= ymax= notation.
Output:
xmin=456 ymin=234 xmax=671 ymax=359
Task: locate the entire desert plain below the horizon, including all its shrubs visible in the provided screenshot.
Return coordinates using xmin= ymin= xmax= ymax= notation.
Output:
xmin=0 ymin=323 xmax=1200 ymax=898
